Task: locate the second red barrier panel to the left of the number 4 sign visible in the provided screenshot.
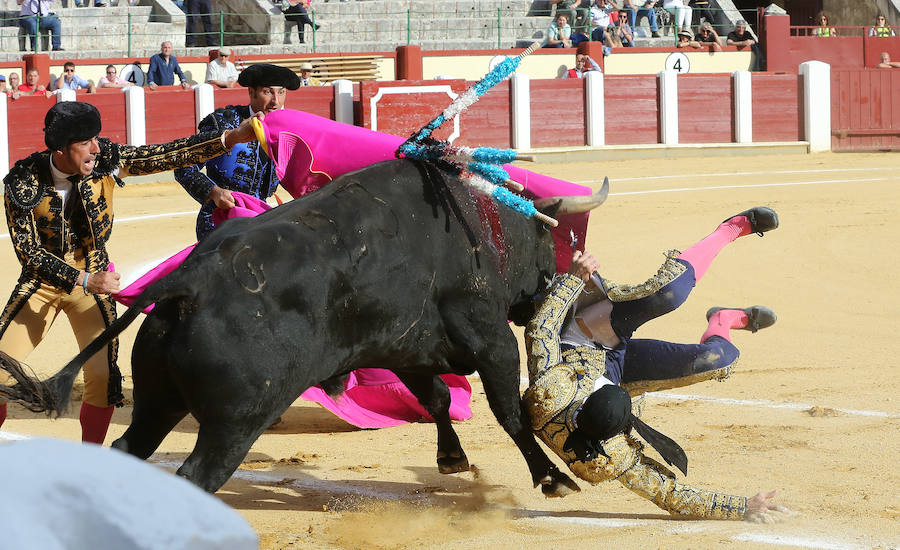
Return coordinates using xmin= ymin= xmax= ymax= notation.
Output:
xmin=531 ymin=78 xmax=587 ymax=147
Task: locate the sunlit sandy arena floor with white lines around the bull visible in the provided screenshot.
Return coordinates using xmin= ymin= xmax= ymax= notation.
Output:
xmin=0 ymin=154 xmax=900 ymax=549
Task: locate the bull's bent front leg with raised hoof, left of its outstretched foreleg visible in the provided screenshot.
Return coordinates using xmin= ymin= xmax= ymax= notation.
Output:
xmin=396 ymin=373 xmax=469 ymax=474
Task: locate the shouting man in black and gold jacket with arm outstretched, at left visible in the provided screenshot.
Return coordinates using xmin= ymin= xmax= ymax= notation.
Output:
xmin=0 ymin=102 xmax=255 ymax=444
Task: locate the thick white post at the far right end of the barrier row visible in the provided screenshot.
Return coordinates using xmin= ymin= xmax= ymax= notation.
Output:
xmin=800 ymin=61 xmax=831 ymax=153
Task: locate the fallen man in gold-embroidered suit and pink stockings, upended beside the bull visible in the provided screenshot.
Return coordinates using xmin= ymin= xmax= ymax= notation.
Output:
xmin=523 ymin=207 xmax=784 ymax=520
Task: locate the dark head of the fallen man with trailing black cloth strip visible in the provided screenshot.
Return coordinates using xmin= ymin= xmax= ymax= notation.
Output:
xmin=563 ymin=384 xmax=688 ymax=475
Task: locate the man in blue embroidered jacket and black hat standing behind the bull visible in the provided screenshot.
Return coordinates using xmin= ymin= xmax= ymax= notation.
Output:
xmin=175 ymin=63 xmax=300 ymax=239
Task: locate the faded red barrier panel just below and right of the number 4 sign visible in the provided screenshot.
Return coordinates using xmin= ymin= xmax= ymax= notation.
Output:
xmin=678 ymin=74 xmax=734 ymax=143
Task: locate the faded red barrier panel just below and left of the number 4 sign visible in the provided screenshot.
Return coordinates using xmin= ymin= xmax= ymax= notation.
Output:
xmin=604 ymin=75 xmax=660 ymax=145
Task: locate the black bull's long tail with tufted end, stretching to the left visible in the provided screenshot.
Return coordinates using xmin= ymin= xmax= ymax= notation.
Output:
xmin=0 ymin=270 xmax=190 ymax=416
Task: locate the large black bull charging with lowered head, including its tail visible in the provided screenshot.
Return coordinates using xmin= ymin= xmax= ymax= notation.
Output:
xmin=0 ymin=161 xmax=577 ymax=495
